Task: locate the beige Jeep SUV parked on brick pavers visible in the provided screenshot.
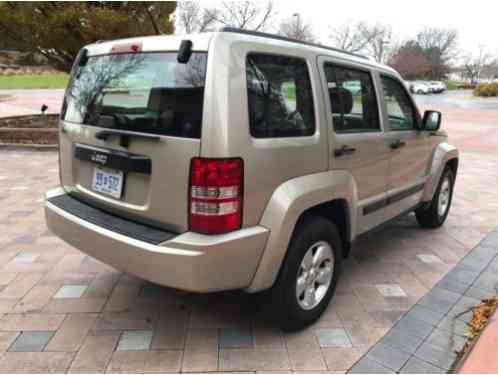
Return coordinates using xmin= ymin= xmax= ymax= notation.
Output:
xmin=45 ymin=28 xmax=458 ymax=329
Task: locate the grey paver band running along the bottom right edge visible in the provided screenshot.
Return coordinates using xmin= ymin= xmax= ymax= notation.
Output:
xmin=348 ymin=230 xmax=498 ymax=373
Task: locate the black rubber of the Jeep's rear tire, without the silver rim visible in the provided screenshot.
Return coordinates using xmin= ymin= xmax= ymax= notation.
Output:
xmin=271 ymin=215 xmax=343 ymax=331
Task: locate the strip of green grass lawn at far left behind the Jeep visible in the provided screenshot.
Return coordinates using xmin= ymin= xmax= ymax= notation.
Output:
xmin=0 ymin=73 xmax=69 ymax=90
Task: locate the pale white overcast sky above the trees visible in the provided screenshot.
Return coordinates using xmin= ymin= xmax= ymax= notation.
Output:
xmin=191 ymin=0 xmax=498 ymax=56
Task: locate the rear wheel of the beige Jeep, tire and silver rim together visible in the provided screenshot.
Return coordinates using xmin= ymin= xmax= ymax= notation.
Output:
xmin=272 ymin=216 xmax=343 ymax=330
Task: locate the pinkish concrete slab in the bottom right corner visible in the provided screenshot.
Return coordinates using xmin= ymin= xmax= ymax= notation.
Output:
xmin=459 ymin=311 xmax=498 ymax=374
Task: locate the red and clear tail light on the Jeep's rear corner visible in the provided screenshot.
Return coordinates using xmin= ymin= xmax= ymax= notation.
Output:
xmin=189 ymin=158 xmax=244 ymax=234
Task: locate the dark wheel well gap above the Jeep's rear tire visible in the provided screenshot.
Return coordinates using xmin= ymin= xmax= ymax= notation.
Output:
xmin=296 ymin=199 xmax=351 ymax=257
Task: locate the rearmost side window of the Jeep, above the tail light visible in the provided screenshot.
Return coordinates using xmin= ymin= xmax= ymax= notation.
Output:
xmin=246 ymin=54 xmax=315 ymax=138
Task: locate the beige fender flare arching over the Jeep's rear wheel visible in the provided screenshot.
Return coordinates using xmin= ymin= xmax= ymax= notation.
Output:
xmin=245 ymin=170 xmax=358 ymax=293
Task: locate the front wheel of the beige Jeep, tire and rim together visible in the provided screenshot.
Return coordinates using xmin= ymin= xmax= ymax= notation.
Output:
xmin=415 ymin=167 xmax=455 ymax=228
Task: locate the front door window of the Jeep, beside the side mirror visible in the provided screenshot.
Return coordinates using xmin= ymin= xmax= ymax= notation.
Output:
xmin=381 ymin=76 xmax=417 ymax=130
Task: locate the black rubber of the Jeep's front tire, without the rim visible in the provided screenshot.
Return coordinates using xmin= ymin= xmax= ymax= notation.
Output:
xmin=415 ymin=167 xmax=455 ymax=228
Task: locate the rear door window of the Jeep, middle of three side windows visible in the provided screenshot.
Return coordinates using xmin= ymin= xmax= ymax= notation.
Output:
xmin=324 ymin=64 xmax=380 ymax=133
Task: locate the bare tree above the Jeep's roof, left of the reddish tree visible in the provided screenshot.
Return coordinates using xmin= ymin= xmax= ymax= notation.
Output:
xmin=330 ymin=21 xmax=392 ymax=62
